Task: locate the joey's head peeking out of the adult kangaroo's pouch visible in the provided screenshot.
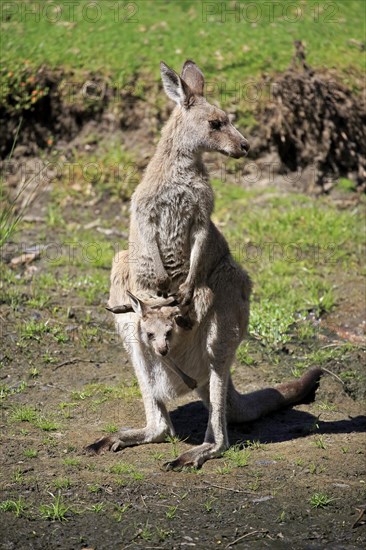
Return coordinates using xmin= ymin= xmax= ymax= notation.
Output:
xmin=128 ymin=292 xmax=192 ymax=357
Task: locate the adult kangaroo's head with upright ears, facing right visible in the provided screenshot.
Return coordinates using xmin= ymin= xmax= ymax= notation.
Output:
xmin=160 ymin=60 xmax=249 ymax=158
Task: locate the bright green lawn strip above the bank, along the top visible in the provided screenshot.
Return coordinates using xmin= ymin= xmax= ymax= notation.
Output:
xmin=2 ymin=0 xmax=364 ymax=83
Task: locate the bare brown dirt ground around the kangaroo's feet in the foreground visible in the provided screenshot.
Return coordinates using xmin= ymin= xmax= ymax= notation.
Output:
xmin=0 ymin=334 xmax=366 ymax=549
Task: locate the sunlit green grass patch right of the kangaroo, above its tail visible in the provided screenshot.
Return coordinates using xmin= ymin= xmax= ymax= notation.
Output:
xmin=213 ymin=181 xmax=364 ymax=352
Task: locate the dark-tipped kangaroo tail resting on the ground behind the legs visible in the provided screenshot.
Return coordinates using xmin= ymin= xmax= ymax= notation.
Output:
xmin=227 ymin=367 xmax=323 ymax=423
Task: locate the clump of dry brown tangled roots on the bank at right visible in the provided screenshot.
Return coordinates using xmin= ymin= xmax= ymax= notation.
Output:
xmin=261 ymin=41 xmax=366 ymax=191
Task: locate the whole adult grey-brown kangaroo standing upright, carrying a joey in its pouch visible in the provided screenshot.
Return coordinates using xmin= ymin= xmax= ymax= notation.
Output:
xmin=88 ymin=61 xmax=321 ymax=469
